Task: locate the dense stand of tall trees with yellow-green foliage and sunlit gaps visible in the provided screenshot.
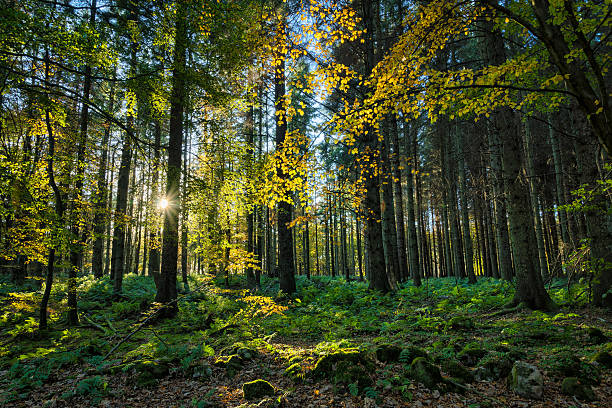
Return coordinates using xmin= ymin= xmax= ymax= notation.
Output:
xmin=0 ymin=0 xmax=612 ymax=334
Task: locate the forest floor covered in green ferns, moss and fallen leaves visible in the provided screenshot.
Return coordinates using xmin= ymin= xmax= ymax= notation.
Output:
xmin=0 ymin=275 xmax=612 ymax=408
